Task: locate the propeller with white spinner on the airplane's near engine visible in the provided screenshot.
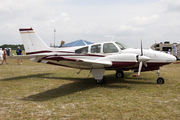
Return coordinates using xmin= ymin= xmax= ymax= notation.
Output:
xmin=137 ymin=38 xmax=150 ymax=76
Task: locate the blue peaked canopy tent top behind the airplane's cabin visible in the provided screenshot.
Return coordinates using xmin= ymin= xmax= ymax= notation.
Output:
xmin=62 ymin=40 xmax=93 ymax=47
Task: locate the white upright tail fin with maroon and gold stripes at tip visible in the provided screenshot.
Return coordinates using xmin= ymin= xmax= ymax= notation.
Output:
xmin=19 ymin=28 xmax=50 ymax=54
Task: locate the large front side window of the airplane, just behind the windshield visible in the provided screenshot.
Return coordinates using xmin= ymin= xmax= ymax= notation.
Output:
xmin=103 ymin=43 xmax=119 ymax=53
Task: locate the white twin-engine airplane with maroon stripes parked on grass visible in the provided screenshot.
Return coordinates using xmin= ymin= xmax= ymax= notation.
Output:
xmin=13 ymin=28 xmax=176 ymax=84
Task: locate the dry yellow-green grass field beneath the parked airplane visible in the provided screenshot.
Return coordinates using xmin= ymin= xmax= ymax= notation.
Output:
xmin=0 ymin=53 xmax=180 ymax=120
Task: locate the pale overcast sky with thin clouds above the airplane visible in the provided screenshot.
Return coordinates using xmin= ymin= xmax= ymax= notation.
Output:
xmin=0 ymin=0 xmax=180 ymax=48
